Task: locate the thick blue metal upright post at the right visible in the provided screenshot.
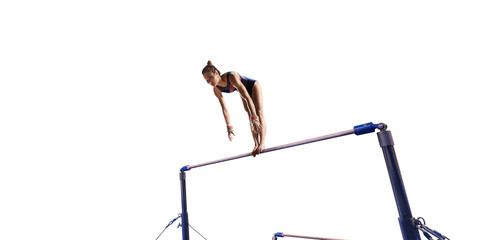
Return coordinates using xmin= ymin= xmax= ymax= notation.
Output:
xmin=377 ymin=128 xmax=420 ymax=240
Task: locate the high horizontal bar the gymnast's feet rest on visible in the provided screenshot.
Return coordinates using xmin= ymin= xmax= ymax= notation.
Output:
xmin=180 ymin=122 xmax=386 ymax=172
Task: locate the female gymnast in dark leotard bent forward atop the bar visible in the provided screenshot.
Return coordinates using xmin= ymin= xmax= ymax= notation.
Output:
xmin=202 ymin=60 xmax=267 ymax=157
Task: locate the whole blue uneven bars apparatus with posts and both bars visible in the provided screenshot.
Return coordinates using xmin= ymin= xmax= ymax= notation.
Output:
xmin=173 ymin=122 xmax=449 ymax=240
